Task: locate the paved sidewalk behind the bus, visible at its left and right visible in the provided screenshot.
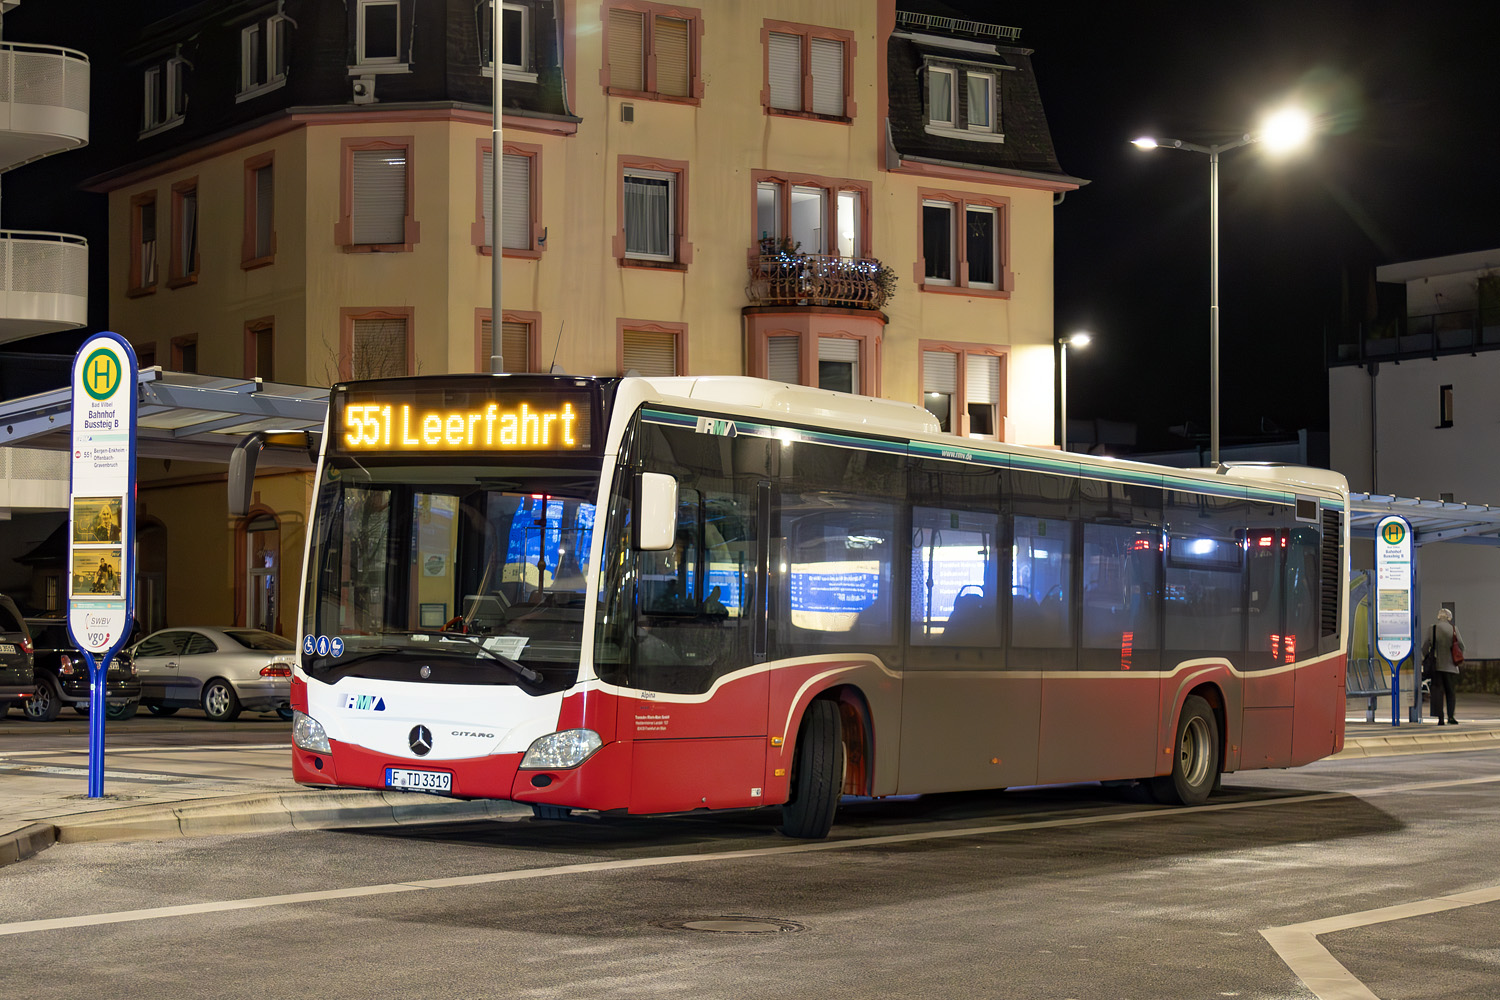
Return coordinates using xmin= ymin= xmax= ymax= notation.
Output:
xmin=0 ymin=694 xmax=1500 ymax=865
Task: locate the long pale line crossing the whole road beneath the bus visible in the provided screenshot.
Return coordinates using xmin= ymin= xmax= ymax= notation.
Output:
xmin=0 ymin=775 xmax=1500 ymax=941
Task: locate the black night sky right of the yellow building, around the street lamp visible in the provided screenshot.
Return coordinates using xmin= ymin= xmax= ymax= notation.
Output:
xmin=978 ymin=0 xmax=1500 ymax=447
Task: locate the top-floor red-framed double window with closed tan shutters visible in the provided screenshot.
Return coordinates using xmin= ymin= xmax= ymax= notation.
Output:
xmin=600 ymin=0 xmax=704 ymax=103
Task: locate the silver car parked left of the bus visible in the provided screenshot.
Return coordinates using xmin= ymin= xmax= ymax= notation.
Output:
xmin=131 ymin=625 xmax=297 ymax=723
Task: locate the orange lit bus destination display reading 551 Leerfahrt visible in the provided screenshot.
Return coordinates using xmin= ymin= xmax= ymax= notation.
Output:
xmin=332 ymin=388 xmax=594 ymax=454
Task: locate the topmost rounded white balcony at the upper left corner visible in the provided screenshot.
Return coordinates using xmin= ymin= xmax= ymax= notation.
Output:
xmin=0 ymin=42 xmax=89 ymax=172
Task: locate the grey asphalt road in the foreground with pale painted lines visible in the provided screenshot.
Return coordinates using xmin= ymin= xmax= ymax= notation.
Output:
xmin=0 ymin=751 xmax=1500 ymax=1000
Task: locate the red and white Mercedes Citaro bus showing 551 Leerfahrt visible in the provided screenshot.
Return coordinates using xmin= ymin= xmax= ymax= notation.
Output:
xmin=293 ymin=375 xmax=1349 ymax=837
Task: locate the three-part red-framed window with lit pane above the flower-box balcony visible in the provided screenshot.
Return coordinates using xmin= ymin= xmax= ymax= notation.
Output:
xmin=752 ymin=171 xmax=870 ymax=256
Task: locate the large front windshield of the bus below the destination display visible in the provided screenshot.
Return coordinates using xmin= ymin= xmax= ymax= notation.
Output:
xmin=302 ymin=460 xmax=599 ymax=694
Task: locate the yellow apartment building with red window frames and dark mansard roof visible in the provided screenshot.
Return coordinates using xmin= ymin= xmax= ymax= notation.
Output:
xmin=79 ymin=0 xmax=1085 ymax=634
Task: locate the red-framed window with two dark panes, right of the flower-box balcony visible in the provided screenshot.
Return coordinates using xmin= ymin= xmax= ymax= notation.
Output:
xmin=917 ymin=192 xmax=1014 ymax=295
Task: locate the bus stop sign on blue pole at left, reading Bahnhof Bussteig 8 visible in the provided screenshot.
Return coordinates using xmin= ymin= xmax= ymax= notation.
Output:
xmin=68 ymin=331 xmax=138 ymax=799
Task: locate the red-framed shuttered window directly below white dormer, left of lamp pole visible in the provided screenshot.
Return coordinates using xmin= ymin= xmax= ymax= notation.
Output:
xmin=335 ymin=136 xmax=419 ymax=252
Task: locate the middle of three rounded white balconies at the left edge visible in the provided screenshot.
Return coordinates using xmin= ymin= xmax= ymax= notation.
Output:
xmin=0 ymin=229 xmax=89 ymax=343
